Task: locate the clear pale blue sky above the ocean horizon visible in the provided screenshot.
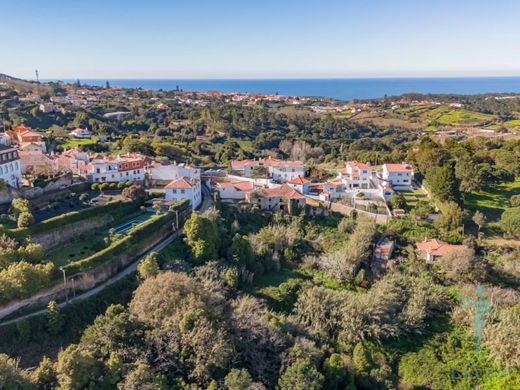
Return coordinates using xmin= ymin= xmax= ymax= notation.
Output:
xmin=4 ymin=0 xmax=520 ymax=79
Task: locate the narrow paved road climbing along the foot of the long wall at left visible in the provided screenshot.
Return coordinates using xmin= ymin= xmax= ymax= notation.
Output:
xmin=0 ymin=185 xmax=213 ymax=326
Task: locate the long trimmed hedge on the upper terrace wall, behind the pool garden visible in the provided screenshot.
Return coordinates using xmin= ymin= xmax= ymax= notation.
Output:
xmin=11 ymin=201 xmax=141 ymax=238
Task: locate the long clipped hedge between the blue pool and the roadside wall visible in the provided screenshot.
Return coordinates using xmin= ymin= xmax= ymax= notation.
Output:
xmin=63 ymin=200 xmax=189 ymax=275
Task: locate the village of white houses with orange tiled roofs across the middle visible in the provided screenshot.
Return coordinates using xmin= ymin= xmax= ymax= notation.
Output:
xmin=0 ymin=120 xmax=463 ymax=276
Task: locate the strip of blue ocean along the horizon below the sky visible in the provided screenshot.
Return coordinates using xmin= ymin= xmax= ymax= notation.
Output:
xmin=46 ymin=77 xmax=520 ymax=100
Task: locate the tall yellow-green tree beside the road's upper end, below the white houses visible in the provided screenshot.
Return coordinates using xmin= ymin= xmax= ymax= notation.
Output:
xmin=184 ymin=211 xmax=220 ymax=264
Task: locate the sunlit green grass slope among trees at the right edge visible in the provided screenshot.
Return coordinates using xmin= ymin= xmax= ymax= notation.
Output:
xmin=464 ymin=177 xmax=520 ymax=222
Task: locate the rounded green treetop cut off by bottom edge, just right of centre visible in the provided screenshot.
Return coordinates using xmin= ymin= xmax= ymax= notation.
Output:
xmin=278 ymin=359 xmax=324 ymax=390
